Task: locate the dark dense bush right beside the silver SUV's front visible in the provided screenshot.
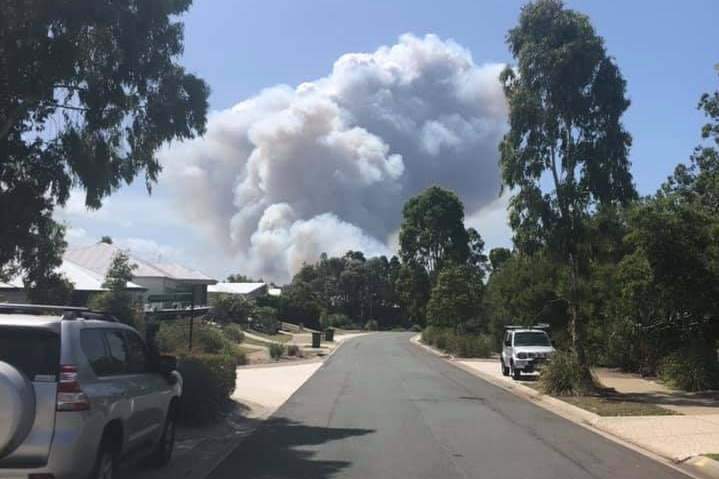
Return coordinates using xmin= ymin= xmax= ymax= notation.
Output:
xmin=178 ymin=354 xmax=237 ymax=425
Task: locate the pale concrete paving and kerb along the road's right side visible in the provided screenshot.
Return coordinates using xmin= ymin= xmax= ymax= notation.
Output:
xmin=412 ymin=336 xmax=719 ymax=479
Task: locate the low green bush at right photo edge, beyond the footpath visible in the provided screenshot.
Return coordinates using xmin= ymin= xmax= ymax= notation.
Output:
xmin=659 ymin=349 xmax=719 ymax=391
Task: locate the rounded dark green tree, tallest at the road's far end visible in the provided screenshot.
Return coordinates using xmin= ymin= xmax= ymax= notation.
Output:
xmin=399 ymin=186 xmax=472 ymax=278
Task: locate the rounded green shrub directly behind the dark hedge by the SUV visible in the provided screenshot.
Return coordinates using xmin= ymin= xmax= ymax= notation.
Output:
xmin=155 ymin=320 xmax=225 ymax=354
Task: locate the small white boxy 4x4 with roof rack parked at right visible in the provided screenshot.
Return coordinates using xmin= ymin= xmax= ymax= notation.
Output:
xmin=500 ymin=326 xmax=554 ymax=379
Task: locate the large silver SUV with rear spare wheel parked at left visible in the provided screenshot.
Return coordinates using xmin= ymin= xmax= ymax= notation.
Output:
xmin=0 ymin=303 xmax=182 ymax=479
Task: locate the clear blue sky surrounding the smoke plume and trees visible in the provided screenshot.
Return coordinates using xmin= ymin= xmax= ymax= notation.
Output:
xmin=61 ymin=0 xmax=719 ymax=282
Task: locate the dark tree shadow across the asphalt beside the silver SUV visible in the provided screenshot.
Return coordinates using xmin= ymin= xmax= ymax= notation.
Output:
xmin=209 ymin=418 xmax=374 ymax=479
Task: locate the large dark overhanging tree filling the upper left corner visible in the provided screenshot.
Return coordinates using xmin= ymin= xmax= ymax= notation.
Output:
xmin=0 ymin=0 xmax=209 ymax=277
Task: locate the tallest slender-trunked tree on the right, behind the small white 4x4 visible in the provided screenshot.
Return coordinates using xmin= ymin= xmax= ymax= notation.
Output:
xmin=499 ymin=0 xmax=636 ymax=372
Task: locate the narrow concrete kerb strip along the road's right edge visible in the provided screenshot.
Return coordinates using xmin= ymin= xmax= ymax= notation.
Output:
xmin=410 ymin=334 xmax=719 ymax=479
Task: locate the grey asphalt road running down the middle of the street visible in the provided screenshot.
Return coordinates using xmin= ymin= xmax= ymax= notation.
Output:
xmin=210 ymin=333 xmax=687 ymax=479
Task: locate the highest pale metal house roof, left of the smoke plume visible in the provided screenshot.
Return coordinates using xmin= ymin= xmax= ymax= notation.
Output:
xmin=65 ymin=243 xmax=216 ymax=284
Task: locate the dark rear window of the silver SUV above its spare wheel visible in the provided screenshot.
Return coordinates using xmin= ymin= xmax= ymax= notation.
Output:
xmin=0 ymin=326 xmax=60 ymax=381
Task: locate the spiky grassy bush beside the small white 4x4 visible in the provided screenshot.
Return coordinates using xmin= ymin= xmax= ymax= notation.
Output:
xmin=540 ymin=351 xmax=595 ymax=396
